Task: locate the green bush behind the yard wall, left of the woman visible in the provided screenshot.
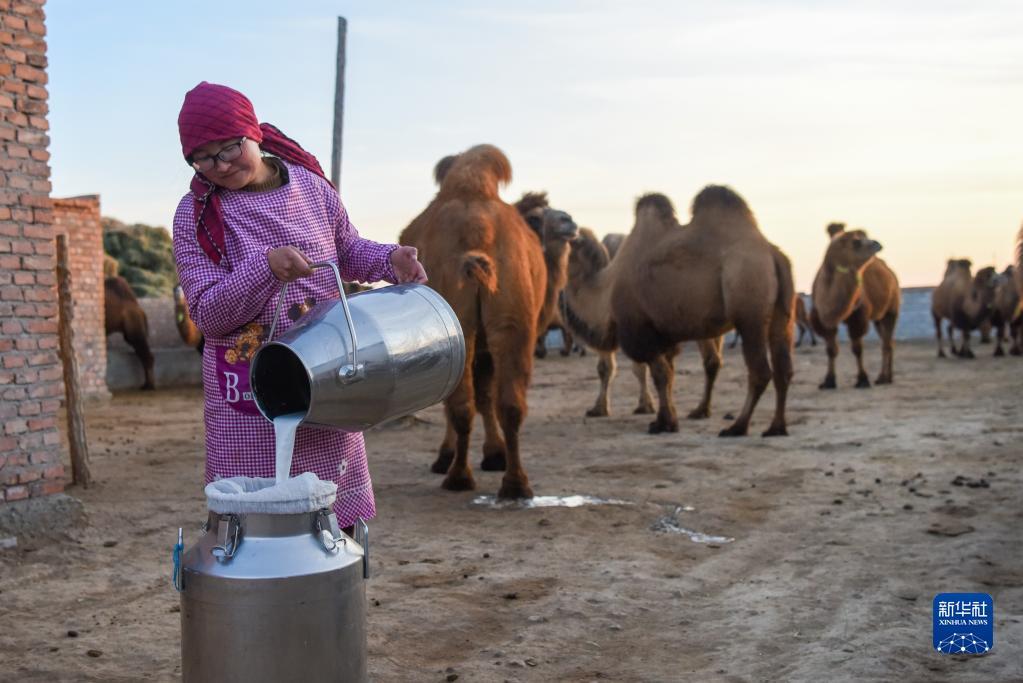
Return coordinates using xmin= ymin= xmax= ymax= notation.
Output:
xmin=103 ymin=218 xmax=178 ymax=297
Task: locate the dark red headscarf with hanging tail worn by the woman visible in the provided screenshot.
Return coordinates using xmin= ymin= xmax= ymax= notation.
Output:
xmin=178 ymin=81 xmax=326 ymax=264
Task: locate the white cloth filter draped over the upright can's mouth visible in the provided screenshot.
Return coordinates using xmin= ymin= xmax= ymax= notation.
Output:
xmin=206 ymin=472 xmax=338 ymax=514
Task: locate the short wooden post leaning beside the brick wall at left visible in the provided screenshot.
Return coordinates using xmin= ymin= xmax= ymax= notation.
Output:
xmin=57 ymin=234 xmax=92 ymax=489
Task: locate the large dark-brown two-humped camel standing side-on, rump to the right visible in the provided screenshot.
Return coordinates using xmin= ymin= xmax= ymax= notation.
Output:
xmin=566 ymin=185 xmax=796 ymax=437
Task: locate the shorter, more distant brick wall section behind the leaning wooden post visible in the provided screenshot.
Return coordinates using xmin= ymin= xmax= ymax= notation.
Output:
xmin=53 ymin=194 xmax=110 ymax=398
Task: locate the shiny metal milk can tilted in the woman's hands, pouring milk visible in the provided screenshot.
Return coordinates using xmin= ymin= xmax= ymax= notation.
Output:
xmin=250 ymin=258 xmax=465 ymax=431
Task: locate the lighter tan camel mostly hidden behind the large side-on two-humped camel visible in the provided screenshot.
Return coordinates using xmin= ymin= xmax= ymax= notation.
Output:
xmin=565 ymin=228 xmax=723 ymax=419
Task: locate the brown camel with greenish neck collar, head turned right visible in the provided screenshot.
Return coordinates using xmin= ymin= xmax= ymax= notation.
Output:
xmin=810 ymin=223 xmax=901 ymax=389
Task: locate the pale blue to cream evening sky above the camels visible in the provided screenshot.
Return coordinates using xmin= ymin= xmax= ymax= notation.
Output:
xmin=45 ymin=0 xmax=1023 ymax=290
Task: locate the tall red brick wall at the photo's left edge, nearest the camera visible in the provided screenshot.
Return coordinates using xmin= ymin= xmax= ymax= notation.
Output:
xmin=0 ymin=0 xmax=64 ymax=502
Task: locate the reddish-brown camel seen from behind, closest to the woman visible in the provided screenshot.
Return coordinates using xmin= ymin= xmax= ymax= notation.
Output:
xmin=400 ymin=145 xmax=546 ymax=498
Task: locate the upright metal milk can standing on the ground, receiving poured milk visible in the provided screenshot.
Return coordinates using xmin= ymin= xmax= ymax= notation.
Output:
xmin=175 ymin=496 xmax=368 ymax=683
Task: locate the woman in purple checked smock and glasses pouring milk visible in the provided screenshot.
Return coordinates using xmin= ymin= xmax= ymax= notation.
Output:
xmin=174 ymin=81 xmax=427 ymax=527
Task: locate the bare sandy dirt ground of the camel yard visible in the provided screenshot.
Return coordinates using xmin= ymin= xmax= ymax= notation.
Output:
xmin=0 ymin=344 xmax=1023 ymax=681
